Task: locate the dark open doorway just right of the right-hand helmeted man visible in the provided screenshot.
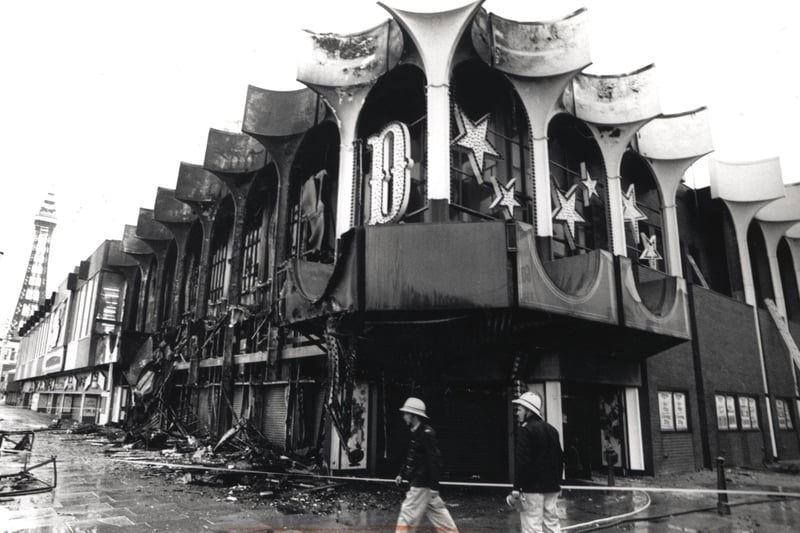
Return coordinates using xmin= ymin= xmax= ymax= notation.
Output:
xmin=561 ymin=383 xmax=625 ymax=479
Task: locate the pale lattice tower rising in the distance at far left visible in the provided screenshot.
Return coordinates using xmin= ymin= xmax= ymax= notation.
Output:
xmin=6 ymin=193 xmax=56 ymax=340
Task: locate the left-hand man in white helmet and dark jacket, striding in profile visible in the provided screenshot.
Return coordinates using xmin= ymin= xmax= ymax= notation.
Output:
xmin=395 ymin=398 xmax=458 ymax=532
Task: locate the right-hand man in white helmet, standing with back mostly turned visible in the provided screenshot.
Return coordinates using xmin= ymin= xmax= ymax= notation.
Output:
xmin=506 ymin=392 xmax=564 ymax=533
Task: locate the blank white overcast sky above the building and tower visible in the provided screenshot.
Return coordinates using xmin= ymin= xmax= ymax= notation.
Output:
xmin=0 ymin=0 xmax=800 ymax=326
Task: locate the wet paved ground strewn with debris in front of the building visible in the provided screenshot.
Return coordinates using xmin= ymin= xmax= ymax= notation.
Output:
xmin=0 ymin=406 xmax=800 ymax=532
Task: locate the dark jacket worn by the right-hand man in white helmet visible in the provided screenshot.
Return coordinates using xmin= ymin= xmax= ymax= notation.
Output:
xmin=514 ymin=414 xmax=564 ymax=493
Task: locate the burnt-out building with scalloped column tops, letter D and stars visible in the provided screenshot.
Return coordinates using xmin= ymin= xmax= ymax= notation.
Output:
xmin=12 ymin=2 xmax=800 ymax=481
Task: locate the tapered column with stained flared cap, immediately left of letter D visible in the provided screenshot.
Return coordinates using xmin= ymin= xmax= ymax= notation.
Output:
xmin=296 ymin=21 xmax=403 ymax=238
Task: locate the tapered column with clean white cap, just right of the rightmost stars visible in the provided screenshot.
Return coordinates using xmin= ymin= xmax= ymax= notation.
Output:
xmin=635 ymin=107 xmax=713 ymax=277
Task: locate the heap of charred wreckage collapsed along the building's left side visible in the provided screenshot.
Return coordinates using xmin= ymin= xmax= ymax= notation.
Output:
xmin=123 ymin=306 xmax=365 ymax=471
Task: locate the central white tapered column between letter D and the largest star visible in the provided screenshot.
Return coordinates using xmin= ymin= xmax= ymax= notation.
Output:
xmin=378 ymin=0 xmax=483 ymax=222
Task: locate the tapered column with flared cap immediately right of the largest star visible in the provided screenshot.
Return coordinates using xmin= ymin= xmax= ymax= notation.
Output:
xmin=472 ymin=9 xmax=591 ymax=237
